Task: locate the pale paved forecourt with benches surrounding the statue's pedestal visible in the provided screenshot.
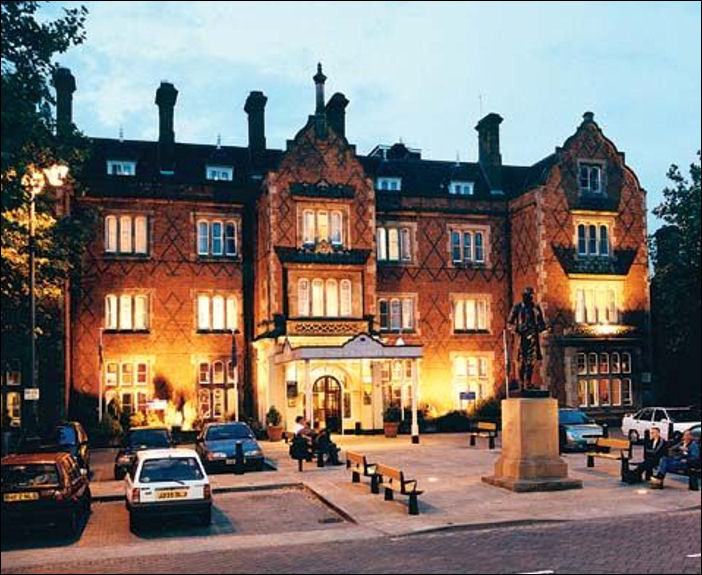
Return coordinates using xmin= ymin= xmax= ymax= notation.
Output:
xmin=92 ymin=434 xmax=700 ymax=535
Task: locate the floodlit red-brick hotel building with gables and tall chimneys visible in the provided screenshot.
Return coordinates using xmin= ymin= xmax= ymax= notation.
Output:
xmin=6 ymin=67 xmax=650 ymax=430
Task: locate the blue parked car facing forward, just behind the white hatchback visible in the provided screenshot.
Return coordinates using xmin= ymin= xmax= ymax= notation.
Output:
xmin=195 ymin=422 xmax=264 ymax=471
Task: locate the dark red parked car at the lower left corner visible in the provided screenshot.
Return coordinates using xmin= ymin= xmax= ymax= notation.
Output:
xmin=0 ymin=452 xmax=91 ymax=536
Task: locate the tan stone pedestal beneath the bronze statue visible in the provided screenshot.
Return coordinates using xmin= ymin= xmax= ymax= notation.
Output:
xmin=482 ymin=397 xmax=583 ymax=491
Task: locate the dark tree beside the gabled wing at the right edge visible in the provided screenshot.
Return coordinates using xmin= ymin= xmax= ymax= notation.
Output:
xmin=651 ymin=151 xmax=702 ymax=404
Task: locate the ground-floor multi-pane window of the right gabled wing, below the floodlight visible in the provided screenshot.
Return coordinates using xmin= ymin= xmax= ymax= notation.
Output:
xmin=576 ymin=351 xmax=632 ymax=407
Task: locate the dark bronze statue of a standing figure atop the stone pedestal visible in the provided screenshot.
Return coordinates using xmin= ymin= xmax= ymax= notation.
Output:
xmin=507 ymin=287 xmax=547 ymax=389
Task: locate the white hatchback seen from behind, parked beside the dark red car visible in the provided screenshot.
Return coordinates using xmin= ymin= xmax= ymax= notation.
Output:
xmin=124 ymin=448 xmax=212 ymax=530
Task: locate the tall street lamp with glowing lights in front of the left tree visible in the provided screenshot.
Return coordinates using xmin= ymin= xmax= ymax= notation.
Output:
xmin=22 ymin=164 xmax=68 ymax=431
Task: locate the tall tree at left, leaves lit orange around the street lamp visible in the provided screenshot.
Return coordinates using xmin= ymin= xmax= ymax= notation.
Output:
xmin=0 ymin=0 xmax=92 ymax=426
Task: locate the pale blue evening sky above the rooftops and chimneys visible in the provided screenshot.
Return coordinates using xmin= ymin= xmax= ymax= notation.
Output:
xmin=44 ymin=1 xmax=702 ymax=231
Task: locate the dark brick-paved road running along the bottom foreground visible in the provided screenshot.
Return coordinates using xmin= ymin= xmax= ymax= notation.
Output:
xmin=2 ymin=508 xmax=701 ymax=574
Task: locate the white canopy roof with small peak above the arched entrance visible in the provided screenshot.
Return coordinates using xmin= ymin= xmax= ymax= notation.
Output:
xmin=274 ymin=333 xmax=422 ymax=364
